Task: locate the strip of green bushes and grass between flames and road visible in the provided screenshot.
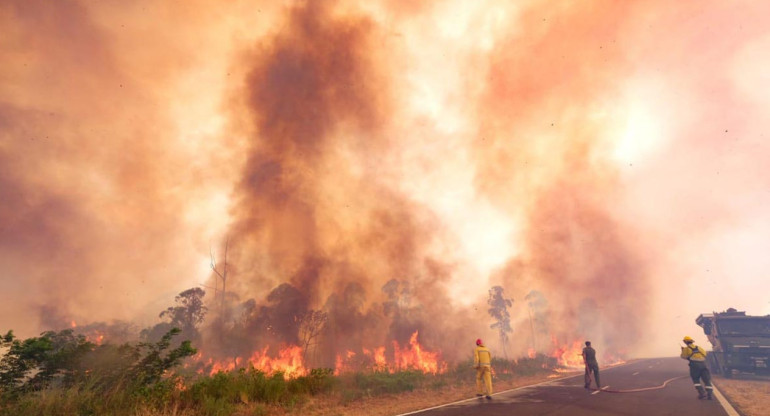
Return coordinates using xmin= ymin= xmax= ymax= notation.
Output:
xmin=0 ymin=328 xmax=555 ymax=416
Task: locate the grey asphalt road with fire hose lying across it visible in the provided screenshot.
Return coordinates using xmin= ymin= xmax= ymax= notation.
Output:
xmin=405 ymin=357 xmax=734 ymax=416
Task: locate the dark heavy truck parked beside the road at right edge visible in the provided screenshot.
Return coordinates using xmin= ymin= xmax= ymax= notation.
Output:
xmin=695 ymin=308 xmax=770 ymax=378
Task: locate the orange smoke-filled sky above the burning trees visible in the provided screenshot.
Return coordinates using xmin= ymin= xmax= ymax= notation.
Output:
xmin=0 ymin=0 xmax=770 ymax=356
